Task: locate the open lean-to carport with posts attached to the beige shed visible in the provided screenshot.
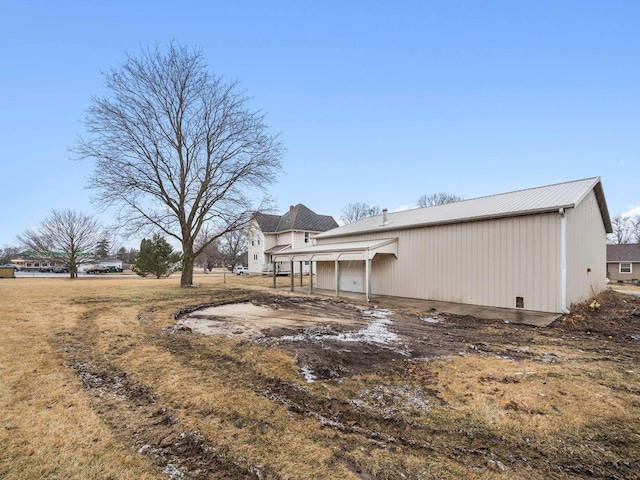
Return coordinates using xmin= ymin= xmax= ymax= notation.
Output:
xmin=272 ymin=238 xmax=398 ymax=301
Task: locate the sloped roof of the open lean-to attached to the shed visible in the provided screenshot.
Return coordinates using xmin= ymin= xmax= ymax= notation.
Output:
xmin=272 ymin=238 xmax=398 ymax=262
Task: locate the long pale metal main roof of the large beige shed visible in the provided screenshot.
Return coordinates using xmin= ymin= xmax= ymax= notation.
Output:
xmin=316 ymin=177 xmax=612 ymax=238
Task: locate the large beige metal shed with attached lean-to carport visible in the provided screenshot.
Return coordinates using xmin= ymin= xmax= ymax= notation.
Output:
xmin=273 ymin=177 xmax=612 ymax=313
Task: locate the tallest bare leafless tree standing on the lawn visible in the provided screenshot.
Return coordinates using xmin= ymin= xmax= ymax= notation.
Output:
xmin=72 ymin=43 xmax=283 ymax=287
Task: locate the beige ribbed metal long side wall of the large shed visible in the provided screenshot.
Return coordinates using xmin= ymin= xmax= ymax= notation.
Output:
xmin=318 ymin=213 xmax=560 ymax=312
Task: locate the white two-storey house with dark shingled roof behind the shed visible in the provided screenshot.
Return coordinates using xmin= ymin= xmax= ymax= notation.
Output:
xmin=247 ymin=203 xmax=338 ymax=273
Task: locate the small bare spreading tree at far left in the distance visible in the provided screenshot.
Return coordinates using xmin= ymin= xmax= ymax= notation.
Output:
xmin=18 ymin=210 xmax=104 ymax=278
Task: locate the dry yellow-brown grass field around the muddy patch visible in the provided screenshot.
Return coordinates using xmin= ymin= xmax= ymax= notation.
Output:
xmin=0 ymin=275 xmax=640 ymax=480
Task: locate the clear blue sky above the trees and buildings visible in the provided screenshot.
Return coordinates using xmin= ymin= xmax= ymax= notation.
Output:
xmin=0 ymin=0 xmax=640 ymax=246
